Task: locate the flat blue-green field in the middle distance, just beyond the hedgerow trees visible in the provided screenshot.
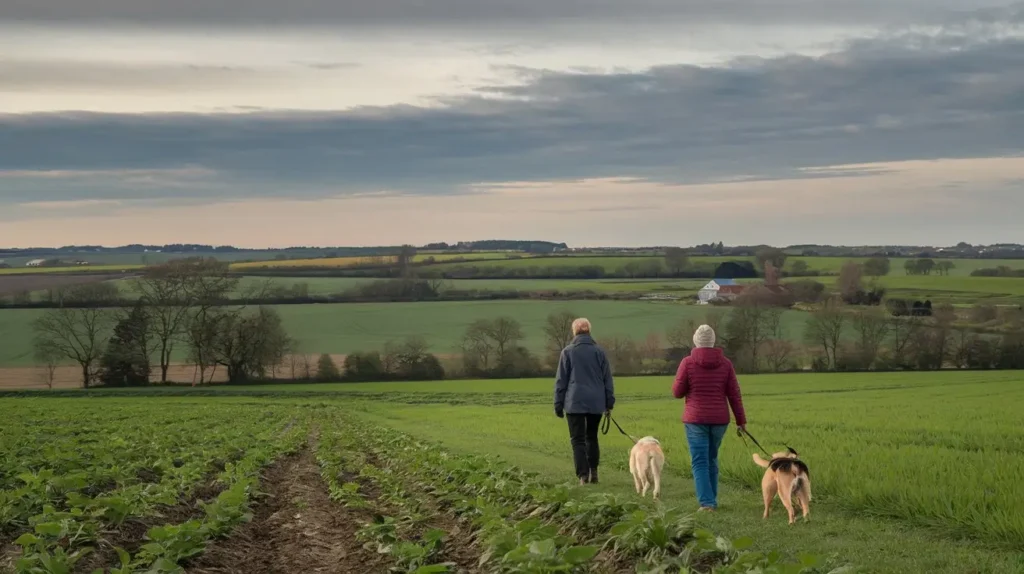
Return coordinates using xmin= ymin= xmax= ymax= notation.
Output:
xmin=0 ymin=300 xmax=806 ymax=367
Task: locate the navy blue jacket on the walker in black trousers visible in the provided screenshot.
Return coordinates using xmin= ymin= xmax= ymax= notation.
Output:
xmin=555 ymin=335 xmax=615 ymax=414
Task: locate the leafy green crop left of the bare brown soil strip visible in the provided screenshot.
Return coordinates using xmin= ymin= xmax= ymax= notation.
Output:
xmin=0 ymin=402 xmax=307 ymax=574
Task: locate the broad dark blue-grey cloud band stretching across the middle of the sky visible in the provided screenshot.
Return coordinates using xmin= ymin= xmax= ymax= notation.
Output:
xmin=0 ymin=17 xmax=1024 ymax=203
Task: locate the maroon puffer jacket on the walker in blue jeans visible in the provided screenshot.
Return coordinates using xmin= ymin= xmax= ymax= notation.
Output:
xmin=672 ymin=348 xmax=746 ymax=425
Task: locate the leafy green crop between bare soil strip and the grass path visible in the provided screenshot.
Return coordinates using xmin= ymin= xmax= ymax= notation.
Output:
xmin=317 ymin=411 xmax=845 ymax=573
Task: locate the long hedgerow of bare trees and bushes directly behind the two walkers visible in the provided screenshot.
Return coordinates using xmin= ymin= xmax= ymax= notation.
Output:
xmin=270 ymin=297 xmax=1024 ymax=382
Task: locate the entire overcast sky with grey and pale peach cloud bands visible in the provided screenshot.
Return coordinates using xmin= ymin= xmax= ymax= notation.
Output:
xmin=0 ymin=0 xmax=1024 ymax=247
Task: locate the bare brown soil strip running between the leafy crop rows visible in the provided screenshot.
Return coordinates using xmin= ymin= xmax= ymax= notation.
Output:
xmin=186 ymin=449 xmax=387 ymax=574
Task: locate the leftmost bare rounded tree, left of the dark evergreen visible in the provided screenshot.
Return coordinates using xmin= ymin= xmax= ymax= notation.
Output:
xmin=34 ymin=283 xmax=117 ymax=388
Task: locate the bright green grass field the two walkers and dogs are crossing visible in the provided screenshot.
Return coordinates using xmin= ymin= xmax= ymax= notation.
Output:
xmin=0 ymin=372 xmax=1024 ymax=574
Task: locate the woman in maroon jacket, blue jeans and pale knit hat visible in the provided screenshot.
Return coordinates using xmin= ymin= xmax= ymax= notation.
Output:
xmin=672 ymin=325 xmax=746 ymax=511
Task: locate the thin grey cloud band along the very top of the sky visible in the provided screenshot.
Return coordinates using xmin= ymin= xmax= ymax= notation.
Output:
xmin=0 ymin=0 xmax=1008 ymax=27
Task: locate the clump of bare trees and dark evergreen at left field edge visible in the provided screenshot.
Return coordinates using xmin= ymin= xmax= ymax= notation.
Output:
xmin=34 ymin=259 xmax=292 ymax=387
